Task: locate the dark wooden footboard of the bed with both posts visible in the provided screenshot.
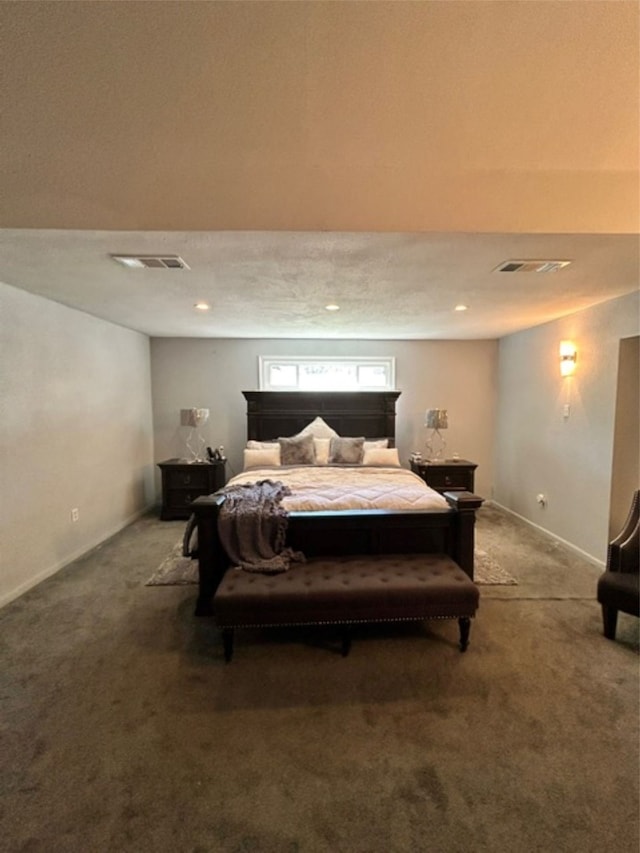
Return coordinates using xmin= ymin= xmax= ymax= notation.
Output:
xmin=192 ymin=492 xmax=483 ymax=616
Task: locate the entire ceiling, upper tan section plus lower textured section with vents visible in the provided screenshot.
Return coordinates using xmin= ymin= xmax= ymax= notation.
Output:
xmin=0 ymin=0 xmax=640 ymax=338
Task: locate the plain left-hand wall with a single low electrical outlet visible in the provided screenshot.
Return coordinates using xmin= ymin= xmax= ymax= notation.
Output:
xmin=0 ymin=284 xmax=154 ymax=605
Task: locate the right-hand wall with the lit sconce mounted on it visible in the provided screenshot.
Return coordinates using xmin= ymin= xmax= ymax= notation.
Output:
xmin=494 ymin=293 xmax=640 ymax=562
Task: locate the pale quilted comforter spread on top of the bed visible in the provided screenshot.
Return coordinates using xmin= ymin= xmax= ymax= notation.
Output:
xmin=227 ymin=465 xmax=449 ymax=512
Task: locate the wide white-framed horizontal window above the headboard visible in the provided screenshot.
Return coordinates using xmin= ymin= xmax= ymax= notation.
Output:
xmin=259 ymin=355 xmax=396 ymax=391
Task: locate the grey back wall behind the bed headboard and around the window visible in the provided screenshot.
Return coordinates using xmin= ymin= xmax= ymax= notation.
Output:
xmin=151 ymin=338 xmax=498 ymax=496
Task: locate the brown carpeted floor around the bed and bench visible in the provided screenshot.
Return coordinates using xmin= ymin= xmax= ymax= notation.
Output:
xmin=0 ymin=507 xmax=639 ymax=853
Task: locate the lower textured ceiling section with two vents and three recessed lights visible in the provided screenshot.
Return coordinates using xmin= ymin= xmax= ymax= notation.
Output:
xmin=0 ymin=230 xmax=638 ymax=339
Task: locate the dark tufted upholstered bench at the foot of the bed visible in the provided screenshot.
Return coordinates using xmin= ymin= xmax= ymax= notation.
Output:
xmin=213 ymin=554 xmax=480 ymax=661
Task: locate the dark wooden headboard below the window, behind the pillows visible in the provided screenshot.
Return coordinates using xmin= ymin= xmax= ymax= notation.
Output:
xmin=242 ymin=391 xmax=401 ymax=447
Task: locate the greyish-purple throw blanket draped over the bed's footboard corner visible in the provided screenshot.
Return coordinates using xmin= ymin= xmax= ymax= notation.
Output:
xmin=218 ymin=480 xmax=304 ymax=574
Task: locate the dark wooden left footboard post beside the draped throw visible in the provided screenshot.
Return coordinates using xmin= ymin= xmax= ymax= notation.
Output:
xmin=191 ymin=493 xmax=228 ymax=616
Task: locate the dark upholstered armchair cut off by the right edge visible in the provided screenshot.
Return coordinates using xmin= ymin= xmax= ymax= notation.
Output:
xmin=598 ymin=490 xmax=640 ymax=640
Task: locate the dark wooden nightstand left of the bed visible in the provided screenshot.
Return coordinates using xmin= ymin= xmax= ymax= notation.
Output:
xmin=158 ymin=459 xmax=226 ymax=521
